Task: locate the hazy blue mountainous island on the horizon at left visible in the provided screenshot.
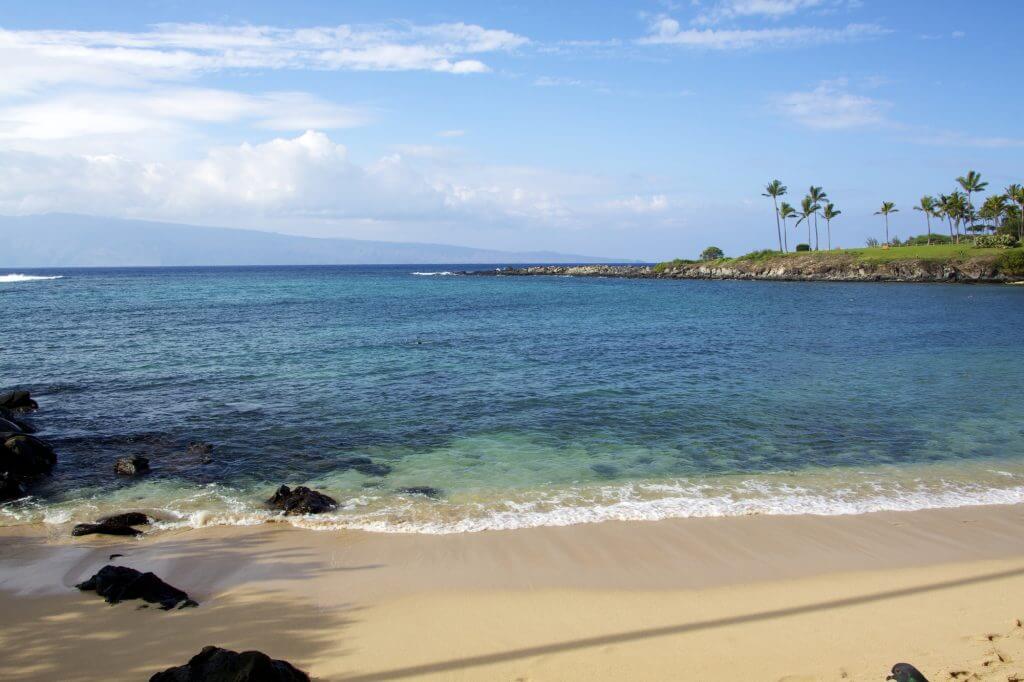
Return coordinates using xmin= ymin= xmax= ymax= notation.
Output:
xmin=0 ymin=213 xmax=622 ymax=268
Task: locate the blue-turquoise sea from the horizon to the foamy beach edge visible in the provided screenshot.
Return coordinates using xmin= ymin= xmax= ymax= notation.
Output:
xmin=0 ymin=266 xmax=1024 ymax=532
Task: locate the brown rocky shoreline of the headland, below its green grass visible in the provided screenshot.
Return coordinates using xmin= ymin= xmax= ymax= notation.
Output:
xmin=466 ymin=246 xmax=1024 ymax=284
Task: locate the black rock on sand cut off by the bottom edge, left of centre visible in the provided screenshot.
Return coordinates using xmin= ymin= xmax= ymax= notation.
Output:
xmin=150 ymin=646 xmax=309 ymax=682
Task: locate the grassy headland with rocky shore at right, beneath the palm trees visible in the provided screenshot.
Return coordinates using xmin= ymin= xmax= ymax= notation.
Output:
xmin=473 ymin=244 xmax=1024 ymax=284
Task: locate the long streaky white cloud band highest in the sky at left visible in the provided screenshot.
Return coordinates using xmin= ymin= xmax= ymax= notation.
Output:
xmin=0 ymin=24 xmax=528 ymax=94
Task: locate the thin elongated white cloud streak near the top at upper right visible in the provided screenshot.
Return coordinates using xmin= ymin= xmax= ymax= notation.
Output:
xmin=637 ymin=16 xmax=889 ymax=50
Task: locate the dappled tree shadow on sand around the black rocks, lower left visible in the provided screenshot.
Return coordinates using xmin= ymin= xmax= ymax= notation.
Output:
xmin=0 ymin=531 xmax=378 ymax=682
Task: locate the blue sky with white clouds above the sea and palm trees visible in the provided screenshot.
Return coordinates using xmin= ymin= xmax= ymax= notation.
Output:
xmin=0 ymin=0 xmax=1024 ymax=259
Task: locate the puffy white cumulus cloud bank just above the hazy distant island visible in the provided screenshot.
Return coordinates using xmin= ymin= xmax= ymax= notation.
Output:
xmin=0 ymin=131 xmax=638 ymax=229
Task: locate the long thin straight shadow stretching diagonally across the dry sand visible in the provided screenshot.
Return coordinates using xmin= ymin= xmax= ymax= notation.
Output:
xmin=343 ymin=567 xmax=1024 ymax=682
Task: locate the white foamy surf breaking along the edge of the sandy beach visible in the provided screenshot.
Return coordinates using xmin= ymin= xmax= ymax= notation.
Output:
xmin=18 ymin=479 xmax=1024 ymax=535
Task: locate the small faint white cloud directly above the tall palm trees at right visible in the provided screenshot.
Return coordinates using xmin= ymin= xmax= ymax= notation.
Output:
xmin=774 ymin=79 xmax=890 ymax=130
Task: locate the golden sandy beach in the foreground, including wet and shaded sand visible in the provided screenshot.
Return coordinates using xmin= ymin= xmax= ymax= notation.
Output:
xmin=6 ymin=507 xmax=1024 ymax=681
